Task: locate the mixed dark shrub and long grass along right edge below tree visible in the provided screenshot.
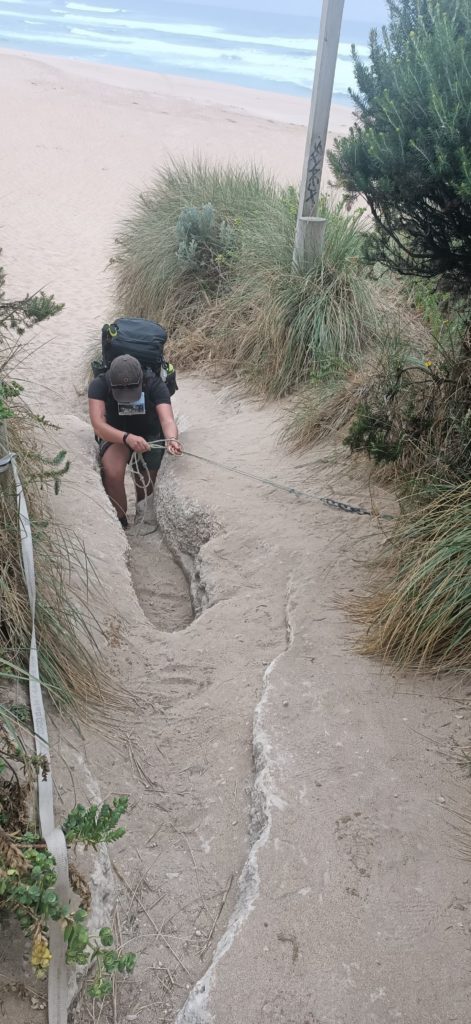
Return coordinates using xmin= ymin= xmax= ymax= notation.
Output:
xmin=345 ymin=313 xmax=471 ymax=670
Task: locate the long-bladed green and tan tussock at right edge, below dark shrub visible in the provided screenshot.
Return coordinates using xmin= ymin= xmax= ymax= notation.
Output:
xmin=357 ymin=481 xmax=471 ymax=669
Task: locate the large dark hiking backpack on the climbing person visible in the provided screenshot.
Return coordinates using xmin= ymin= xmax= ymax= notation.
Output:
xmin=91 ymin=316 xmax=178 ymax=395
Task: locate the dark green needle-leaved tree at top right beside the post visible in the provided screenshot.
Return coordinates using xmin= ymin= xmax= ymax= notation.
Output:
xmin=330 ymin=0 xmax=471 ymax=291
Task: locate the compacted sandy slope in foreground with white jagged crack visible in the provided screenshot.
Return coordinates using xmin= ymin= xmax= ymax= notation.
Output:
xmin=69 ymin=380 xmax=470 ymax=1024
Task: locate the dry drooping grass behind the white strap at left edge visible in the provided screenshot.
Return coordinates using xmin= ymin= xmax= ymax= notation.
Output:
xmin=0 ymin=370 xmax=111 ymax=715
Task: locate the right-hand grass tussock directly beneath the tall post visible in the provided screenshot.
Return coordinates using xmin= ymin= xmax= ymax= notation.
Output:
xmin=203 ymin=193 xmax=376 ymax=397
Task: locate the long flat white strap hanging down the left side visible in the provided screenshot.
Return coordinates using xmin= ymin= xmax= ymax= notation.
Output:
xmin=0 ymin=454 xmax=70 ymax=1024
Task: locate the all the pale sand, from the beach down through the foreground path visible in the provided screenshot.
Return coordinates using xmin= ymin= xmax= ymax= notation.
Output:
xmin=0 ymin=55 xmax=471 ymax=1024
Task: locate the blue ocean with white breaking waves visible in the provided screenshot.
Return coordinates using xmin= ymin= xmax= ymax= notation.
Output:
xmin=0 ymin=0 xmax=369 ymax=103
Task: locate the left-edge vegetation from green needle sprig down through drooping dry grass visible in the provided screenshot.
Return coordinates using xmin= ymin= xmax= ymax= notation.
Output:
xmin=0 ymin=280 xmax=110 ymax=714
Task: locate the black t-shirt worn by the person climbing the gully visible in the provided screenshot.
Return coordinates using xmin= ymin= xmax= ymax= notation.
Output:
xmin=88 ymin=373 xmax=171 ymax=438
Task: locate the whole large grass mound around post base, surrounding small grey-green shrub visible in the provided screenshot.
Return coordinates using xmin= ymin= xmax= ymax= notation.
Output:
xmin=114 ymin=162 xmax=377 ymax=396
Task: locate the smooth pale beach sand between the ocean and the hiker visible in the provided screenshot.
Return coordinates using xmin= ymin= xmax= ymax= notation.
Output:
xmin=0 ymin=51 xmax=352 ymax=395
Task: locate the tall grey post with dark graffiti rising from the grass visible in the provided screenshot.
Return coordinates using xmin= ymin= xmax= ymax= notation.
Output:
xmin=293 ymin=0 xmax=344 ymax=266
